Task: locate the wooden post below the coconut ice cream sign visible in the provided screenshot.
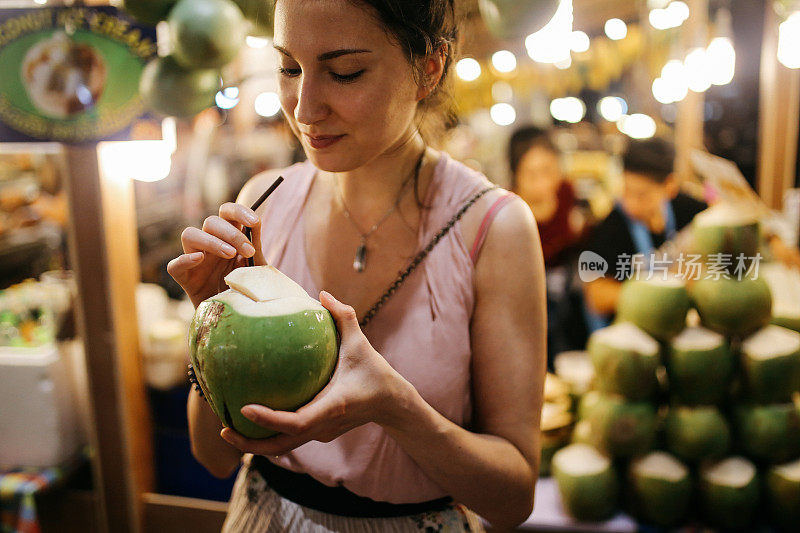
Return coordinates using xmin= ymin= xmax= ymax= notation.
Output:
xmin=66 ymin=144 xmax=154 ymax=533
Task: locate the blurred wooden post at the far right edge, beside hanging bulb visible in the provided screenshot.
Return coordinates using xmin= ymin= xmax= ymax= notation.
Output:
xmin=757 ymin=2 xmax=800 ymax=209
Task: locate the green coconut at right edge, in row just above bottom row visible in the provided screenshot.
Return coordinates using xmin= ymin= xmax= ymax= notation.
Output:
xmin=734 ymin=403 xmax=800 ymax=464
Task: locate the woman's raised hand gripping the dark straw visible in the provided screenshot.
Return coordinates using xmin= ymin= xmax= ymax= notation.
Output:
xmin=167 ymin=202 xmax=266 ymax=307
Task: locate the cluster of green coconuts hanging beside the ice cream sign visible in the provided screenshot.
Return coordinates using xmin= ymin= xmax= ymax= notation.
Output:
xmin=124 ymin=0 xmax=274 ymax=117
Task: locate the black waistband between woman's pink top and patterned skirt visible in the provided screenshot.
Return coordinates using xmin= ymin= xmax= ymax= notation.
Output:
xmin=250 ymin=455 xmax=453 ymax=518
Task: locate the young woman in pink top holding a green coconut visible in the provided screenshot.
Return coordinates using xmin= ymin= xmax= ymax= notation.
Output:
xmin=168 ymin=0 xmax=546 ymax=531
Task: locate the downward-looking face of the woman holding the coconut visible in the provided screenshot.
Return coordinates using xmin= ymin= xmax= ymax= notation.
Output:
xmin=274 ymin=0 xmax=423 ymax=172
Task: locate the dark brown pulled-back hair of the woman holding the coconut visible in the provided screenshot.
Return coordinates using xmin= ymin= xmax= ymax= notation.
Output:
xmin=350 ymin=0 xmax=458 ymax=144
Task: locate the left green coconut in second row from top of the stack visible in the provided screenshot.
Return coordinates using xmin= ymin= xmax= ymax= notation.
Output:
xmin=617 ymin=276 xmax=690 ymax=341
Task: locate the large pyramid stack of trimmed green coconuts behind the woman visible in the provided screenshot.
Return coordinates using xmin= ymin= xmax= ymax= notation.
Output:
xmin=552 ymin=205 xmax=800 ymax=531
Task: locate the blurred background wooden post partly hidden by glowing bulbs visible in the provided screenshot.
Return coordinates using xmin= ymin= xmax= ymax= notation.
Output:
xmin=675 ymin=0 xmax=708 ymax=181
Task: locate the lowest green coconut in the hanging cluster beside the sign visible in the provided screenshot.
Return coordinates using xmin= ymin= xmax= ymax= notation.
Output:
xmin=139 ymin=56 xmax=220 ymax=117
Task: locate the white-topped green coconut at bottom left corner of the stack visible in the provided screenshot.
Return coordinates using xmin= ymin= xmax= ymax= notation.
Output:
xmin=553 ymin=444 xmax=618 ymax=520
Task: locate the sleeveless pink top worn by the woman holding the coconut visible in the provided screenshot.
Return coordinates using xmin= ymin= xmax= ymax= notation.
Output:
xmin=253 ymin=153 xmax=510 ymax=503
